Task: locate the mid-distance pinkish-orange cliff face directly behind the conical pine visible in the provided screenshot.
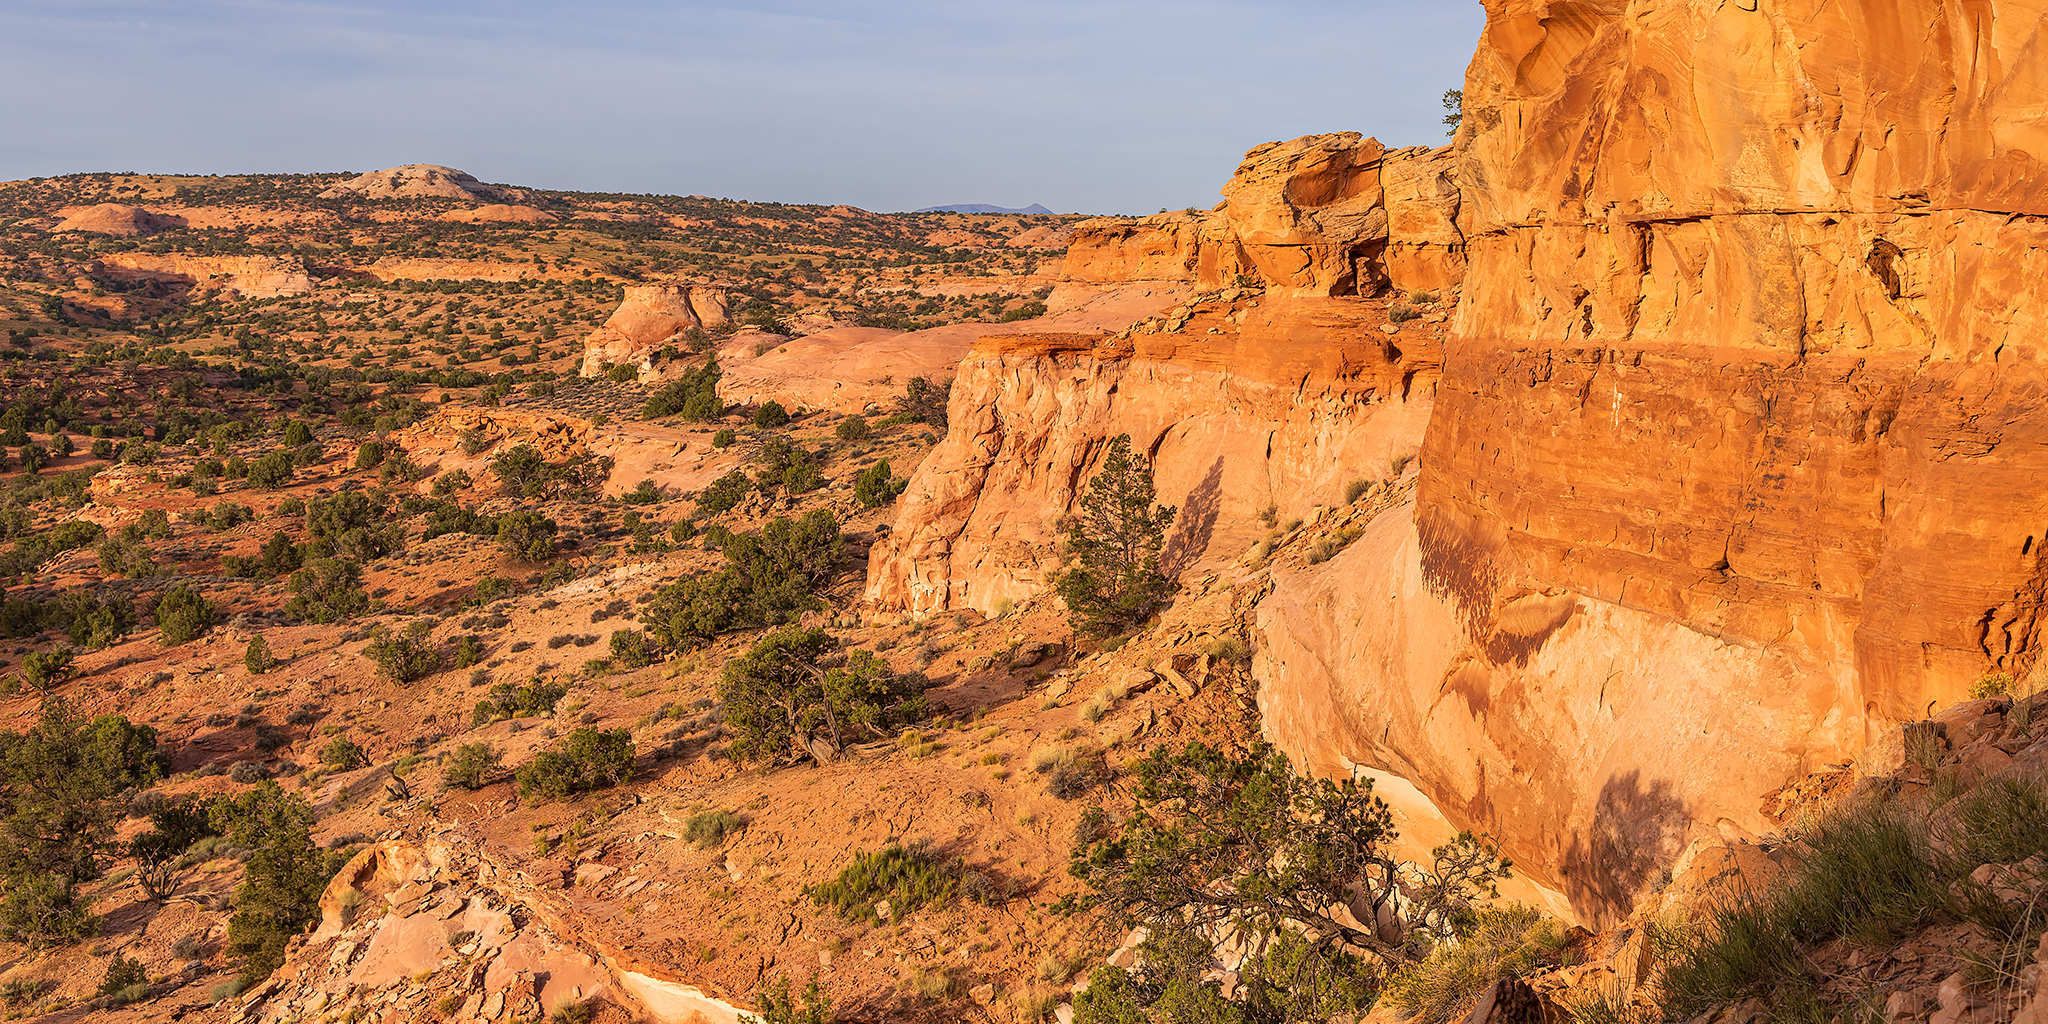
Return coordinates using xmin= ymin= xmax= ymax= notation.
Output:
xmin=866 ymin=293 xmax=1438 ymax=614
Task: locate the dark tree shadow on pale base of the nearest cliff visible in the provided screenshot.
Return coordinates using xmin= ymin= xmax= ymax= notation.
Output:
xmin=1561 ymin=770 xmax=1692 ymax=924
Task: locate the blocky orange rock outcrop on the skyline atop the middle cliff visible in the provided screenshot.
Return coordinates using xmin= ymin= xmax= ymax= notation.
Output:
xmin=1065 ymin=131 xmax=1464 ymax=297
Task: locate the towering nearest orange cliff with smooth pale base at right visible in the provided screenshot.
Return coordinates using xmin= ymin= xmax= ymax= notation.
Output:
xmin=1260 ymin=0 xmax=2048 ymax=920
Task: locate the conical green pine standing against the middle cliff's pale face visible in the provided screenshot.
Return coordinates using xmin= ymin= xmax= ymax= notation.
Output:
xmin=1059 ymin=434 xmax=1176 ymax=637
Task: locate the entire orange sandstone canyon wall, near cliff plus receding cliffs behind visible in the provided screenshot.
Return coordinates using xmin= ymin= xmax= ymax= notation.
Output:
xmin=868 ymin=0 xmax=2048 ymax=922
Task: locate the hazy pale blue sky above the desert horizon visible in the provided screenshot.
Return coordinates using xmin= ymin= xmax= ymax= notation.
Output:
xmin=0 ymin=0 xmax=1485 ymax=213
